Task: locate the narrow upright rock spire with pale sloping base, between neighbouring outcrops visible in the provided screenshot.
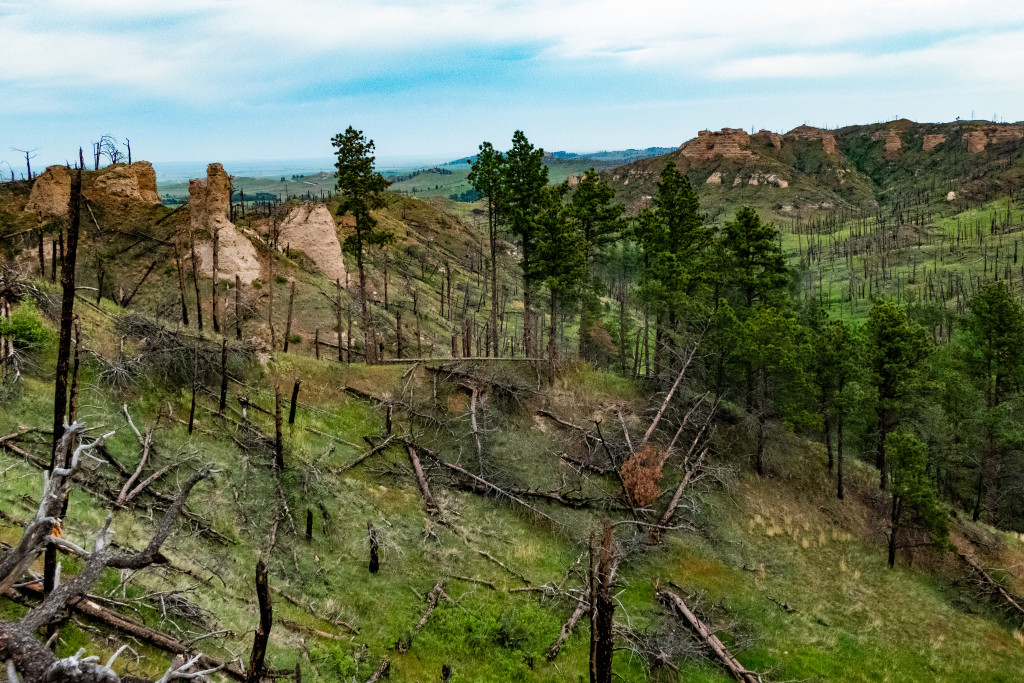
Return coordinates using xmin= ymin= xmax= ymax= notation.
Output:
xmin=188 ymin=164 xmax=260 ymax=285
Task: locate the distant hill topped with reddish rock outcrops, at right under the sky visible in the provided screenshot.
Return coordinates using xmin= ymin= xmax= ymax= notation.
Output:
xmin=608 ymin=119 xmax=1024 ymax=220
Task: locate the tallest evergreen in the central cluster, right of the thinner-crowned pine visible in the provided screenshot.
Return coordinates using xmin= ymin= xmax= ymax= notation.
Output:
xmin=504 ymin=130 xmax=548 ymax=355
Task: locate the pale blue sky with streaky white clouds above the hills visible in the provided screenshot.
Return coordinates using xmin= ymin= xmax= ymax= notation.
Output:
xmin=0 ymin=0 xmax=1024 ymax=173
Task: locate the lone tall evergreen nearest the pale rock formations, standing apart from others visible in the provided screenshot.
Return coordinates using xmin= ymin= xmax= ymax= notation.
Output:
xmin=331 ymin=126 xmax=394 ymax=362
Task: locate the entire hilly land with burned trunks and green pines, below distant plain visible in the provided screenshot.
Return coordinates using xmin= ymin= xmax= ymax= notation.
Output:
xmin=0 ymin=121 xmax=1024 ymax=683
